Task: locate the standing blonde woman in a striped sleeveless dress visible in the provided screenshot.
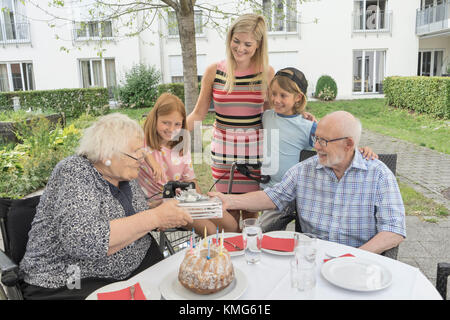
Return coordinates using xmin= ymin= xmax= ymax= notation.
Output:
xmin=187 ymin=14 xmax=274 ymax=226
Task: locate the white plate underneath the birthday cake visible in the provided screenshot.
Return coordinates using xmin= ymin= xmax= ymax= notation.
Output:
xmin=159 ymin=267 xmax=248 ymax=300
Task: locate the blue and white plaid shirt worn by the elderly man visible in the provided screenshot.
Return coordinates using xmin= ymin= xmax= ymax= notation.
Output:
xmin=264 ymin=152 xmax=406 ymax=247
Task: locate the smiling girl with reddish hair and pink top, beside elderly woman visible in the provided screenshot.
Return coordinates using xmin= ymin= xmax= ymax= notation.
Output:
xmin=138 ymin=93 xmax=238 ymax=234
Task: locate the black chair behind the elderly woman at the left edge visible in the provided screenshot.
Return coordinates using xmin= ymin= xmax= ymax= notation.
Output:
xmin=0 ymin=196 xmax=40 ymax=300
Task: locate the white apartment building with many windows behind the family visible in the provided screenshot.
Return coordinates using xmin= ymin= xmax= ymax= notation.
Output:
xmin=0 ymin=0 xmax=450 ymax=99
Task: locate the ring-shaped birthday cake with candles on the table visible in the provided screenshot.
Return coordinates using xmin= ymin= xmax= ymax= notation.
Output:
xmin=178 ymin=240 xmax=234 ymax=294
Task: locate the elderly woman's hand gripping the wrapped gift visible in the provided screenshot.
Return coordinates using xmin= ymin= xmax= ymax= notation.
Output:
xmin=153 ymin=199 xmax=193 ymax=230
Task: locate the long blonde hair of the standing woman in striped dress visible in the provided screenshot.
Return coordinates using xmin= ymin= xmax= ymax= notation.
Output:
xmin=225 ymin=13 xmax=269 ymax=93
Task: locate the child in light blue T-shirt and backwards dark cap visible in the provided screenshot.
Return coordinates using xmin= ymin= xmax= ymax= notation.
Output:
xmin=261 ymin=68 xmax=378 ymax=232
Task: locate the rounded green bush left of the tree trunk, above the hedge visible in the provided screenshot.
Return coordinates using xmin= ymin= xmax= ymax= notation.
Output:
xmin=118 ymin=64 xmax=161 ymax=108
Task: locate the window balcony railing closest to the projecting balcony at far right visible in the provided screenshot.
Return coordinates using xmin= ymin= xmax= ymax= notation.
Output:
xmin=353 ymin=10 xmax=392 ymax=33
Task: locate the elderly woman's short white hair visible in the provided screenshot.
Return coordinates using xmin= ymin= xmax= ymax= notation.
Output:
xmin=76 ymin=113 xmax=144 ymax=162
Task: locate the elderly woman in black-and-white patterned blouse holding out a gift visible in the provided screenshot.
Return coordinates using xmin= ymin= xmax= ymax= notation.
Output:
xmin=20 ymin=113 xmax=192 ymax=299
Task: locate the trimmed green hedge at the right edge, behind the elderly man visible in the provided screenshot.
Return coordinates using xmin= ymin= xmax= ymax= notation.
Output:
xmin=383 ymin=76 xmax=450 ymax=119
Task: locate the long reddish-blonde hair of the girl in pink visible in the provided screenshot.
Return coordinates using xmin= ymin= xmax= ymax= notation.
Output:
xmin=144 ymin=93 xmax=190 ymax=155
